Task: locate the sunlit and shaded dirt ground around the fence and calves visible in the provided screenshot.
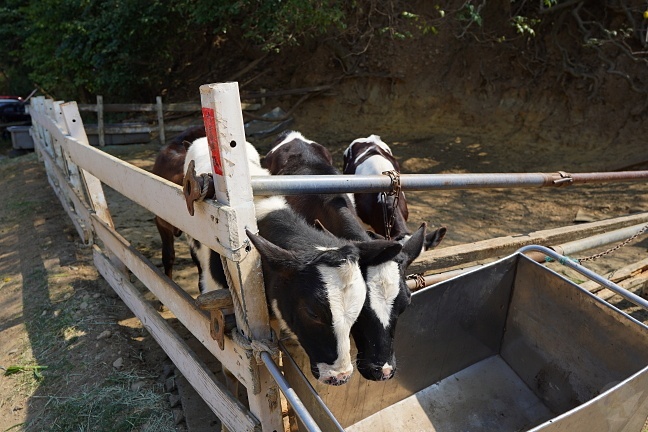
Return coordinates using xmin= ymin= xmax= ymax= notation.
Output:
xmin=0 ymin=110 xmax=648 ymax=431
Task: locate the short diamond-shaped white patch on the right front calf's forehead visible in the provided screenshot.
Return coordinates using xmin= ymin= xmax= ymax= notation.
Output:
xmin=367 ymin=261 xmax=400 ymax=328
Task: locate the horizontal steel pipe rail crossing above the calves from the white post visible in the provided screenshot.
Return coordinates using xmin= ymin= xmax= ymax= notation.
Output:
xmin=251 ymin=171 xmax=648 ymax=195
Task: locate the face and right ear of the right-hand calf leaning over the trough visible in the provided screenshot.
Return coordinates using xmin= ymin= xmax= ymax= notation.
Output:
xmin=351 ymin=224 xmax=425 ymax=381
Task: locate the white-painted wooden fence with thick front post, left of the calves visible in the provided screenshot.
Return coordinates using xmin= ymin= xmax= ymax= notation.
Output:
xmin=31 ymin=88 xmax=284 ymax=431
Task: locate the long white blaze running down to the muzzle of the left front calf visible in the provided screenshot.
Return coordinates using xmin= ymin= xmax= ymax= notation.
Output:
xmin=317 ymin=262 xmax=367 ymax=379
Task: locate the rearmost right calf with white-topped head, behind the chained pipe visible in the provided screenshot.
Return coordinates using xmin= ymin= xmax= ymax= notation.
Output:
xmin=343 ymin=135 xmax=446 ymax=250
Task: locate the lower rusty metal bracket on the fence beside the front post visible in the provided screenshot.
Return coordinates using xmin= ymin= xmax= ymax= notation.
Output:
xmin=196 ymin=289 xmax=236 ymax=350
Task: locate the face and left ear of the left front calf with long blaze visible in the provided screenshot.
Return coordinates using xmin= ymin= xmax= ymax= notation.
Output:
xmin=248 ymin=232 xmax=367 ymax=385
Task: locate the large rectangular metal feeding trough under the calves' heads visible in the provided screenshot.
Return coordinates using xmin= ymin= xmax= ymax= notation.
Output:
xmin=283 ymin=247 xmax=648 ymax=432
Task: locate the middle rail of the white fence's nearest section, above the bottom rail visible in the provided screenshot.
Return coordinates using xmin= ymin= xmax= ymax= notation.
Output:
xmin=92 ymin=217 xmax=252 ymax=387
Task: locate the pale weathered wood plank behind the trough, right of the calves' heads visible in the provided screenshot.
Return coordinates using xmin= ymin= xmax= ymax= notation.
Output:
xmin=408 ymin=213 xmax=648 ymax=273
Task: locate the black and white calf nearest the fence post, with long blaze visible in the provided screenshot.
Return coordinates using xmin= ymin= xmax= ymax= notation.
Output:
xmin=185 ymin=139 xmax=402 ymax=385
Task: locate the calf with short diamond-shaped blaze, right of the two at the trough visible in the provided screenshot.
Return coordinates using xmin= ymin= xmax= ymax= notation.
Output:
xmin=263 ymin=131 xmax=425 ymax=381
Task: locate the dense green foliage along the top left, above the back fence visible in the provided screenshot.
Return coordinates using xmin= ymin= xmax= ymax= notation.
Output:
xmin=0 ymin=0 xmax=345 ymax=101
